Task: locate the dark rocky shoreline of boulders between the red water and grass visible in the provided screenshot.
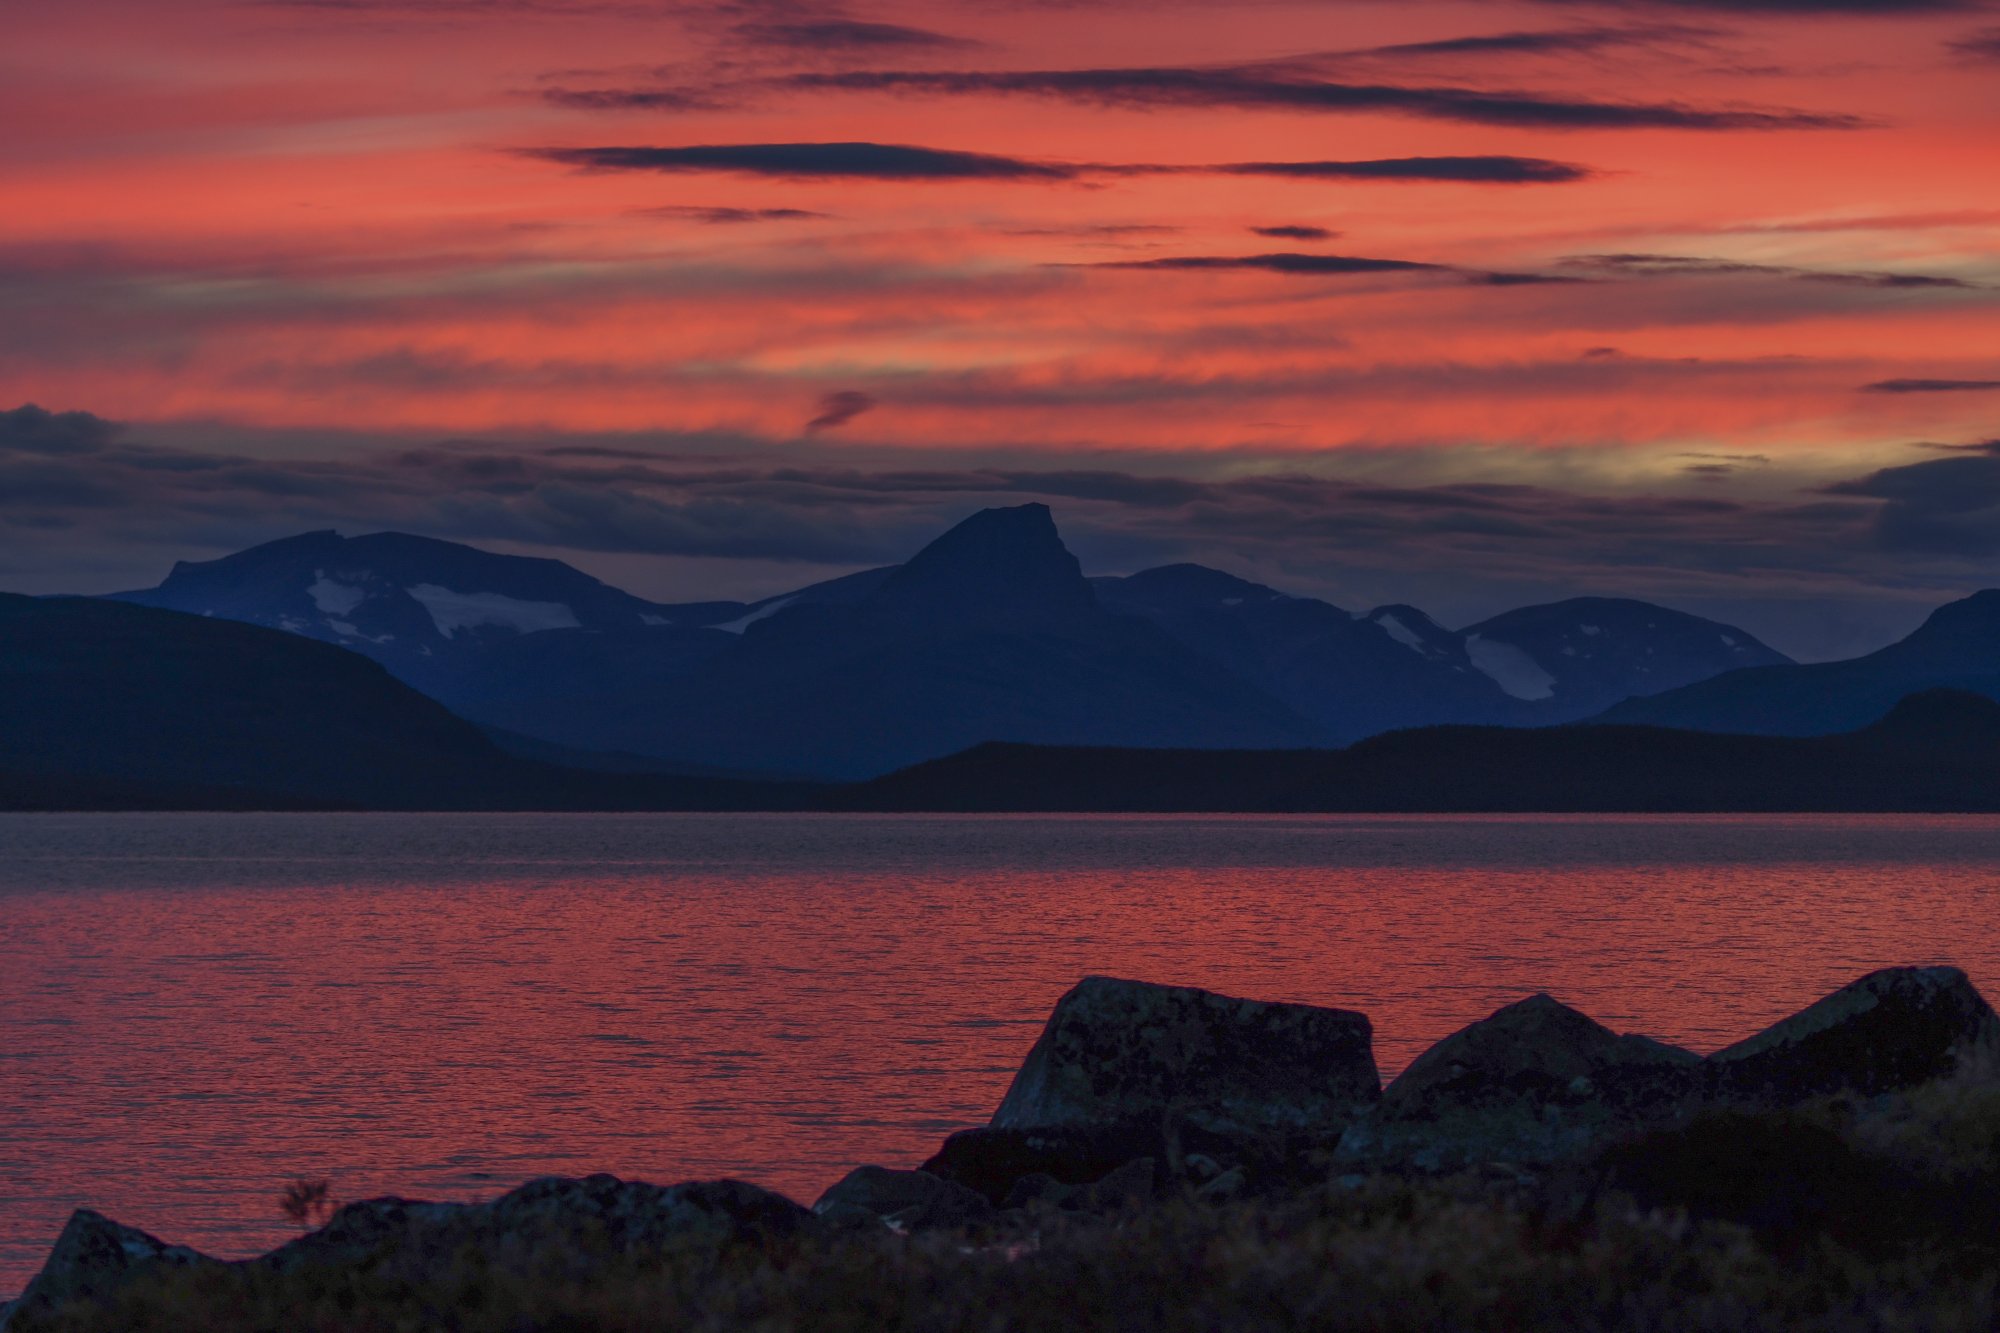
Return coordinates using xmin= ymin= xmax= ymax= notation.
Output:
xmin=0 ymin=967 xmax=2000 ymax=1333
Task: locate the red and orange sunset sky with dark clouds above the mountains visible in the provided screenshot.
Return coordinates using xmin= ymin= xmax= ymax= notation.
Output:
xmin=0 ymin=0 xmax=2000 ymax=658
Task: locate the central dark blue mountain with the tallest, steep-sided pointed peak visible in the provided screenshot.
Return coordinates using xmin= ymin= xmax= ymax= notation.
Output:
xmin=560 ymin=504 xmax=1320 ymax=777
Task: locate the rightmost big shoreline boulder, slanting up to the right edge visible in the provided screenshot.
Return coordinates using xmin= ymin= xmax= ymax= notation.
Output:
xmin=1708 ymin=967 xmax=2000 ymax=1107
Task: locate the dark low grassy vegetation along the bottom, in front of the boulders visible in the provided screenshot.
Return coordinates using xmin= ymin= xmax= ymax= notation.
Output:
xmin=34 ymin=1071 xmax=2000 ymax=1333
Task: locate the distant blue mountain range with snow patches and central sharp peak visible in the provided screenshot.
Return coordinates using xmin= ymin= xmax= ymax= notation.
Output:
xmin=116 ymin=504 xmax=1800 ymax=781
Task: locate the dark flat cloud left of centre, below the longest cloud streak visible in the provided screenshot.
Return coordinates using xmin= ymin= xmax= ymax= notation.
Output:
xmin=522 ymin=142 xmax=1078 ymax=180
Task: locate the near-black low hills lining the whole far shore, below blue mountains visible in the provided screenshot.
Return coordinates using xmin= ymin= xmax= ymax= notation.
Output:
xmin=0 ymin=578 xmax=2000 ymax=811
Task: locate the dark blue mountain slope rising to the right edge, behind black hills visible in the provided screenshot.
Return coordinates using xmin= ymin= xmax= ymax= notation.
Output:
xmin=1600 ymin=590 xmax=2000 ymax=737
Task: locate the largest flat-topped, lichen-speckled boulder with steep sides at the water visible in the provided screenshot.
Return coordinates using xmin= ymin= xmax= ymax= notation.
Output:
xmin=992 ymin=977 xmax=1382 ymax=1133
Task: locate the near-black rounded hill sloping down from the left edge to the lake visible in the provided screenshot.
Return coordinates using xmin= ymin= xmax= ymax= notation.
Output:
xmin=0 ymin=594 xmax=812 ymax=809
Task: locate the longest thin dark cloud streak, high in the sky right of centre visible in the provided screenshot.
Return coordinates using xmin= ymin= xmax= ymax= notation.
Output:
xmin=782 ymin=66 xmax=1864 ymax=130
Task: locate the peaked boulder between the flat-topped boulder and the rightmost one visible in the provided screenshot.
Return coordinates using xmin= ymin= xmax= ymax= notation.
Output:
xmin=1340 ymin=995 xmax=1702 ymax=1169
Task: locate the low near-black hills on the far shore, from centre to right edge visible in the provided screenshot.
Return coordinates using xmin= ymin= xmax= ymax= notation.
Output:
xmin=852 ymin=691 xmax=2000 ymax=813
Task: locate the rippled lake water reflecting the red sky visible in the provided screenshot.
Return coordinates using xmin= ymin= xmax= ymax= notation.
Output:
xmin=0 ymin=815 xmax=2000 ymax=1293
